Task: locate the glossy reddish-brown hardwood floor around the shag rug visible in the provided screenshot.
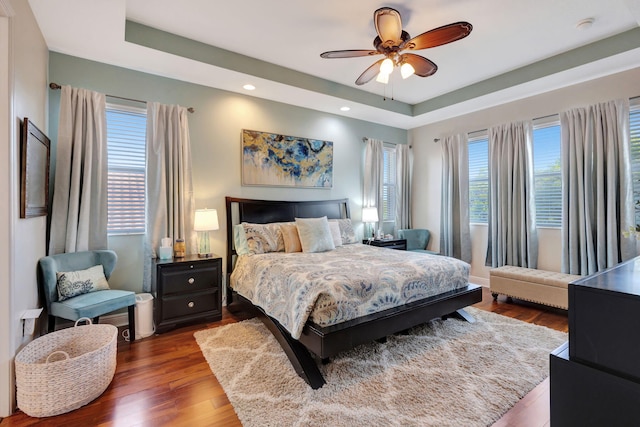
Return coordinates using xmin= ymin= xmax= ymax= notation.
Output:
xmin=0 ymin=288 xmax=568 ymax=427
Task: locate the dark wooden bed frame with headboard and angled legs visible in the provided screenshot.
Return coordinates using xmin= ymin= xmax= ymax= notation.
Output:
xmin=226 ymin=197 xmax=482 ymax=389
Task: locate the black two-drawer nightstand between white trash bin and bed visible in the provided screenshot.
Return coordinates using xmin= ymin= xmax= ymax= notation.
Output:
xmin=151 ymin=255 xmax=222 ymax=333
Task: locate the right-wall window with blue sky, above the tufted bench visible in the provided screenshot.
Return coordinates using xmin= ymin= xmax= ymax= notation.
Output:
xmin=533 ymin=116 xmax=562 ymax=228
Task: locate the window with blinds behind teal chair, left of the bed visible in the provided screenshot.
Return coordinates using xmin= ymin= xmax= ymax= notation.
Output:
xmin=107 ymin=104 xmax=147 ymax=234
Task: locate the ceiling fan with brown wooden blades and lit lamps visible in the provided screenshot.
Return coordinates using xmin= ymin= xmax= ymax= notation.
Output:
xmin=320 ymin=7 xmax=473 ymax=85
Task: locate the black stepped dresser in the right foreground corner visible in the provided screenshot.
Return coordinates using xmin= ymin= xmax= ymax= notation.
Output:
xmin=550 ymin=257 xmax=640 ymax=427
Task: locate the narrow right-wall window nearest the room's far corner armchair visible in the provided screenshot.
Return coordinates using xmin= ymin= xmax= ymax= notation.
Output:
xmin=469 ymin=134 xmax=489 ymax=224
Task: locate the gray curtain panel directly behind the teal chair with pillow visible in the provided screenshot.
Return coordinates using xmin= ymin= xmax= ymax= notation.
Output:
xmin=49 ymin=86 xmax=107 ymax=255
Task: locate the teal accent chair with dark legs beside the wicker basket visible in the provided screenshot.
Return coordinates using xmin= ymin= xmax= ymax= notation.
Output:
xmin=38 ymin=250 xmax=136 ymax=341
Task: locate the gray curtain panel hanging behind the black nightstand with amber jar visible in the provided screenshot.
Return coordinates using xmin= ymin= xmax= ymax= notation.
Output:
xmin=143 ymin=102 xmax=197 ymax=292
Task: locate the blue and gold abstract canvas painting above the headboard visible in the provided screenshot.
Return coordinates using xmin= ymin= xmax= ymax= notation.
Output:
xmin=242 ymin=129 xmax=333 ymax=188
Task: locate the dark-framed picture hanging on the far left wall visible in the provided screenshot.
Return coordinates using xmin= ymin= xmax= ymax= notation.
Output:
xmin=20 ymin=117 xmax=50 ymax=218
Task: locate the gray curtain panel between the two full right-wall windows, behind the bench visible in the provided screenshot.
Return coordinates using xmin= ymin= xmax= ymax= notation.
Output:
xmin=487 ymin=122 xmax=538 ymax=268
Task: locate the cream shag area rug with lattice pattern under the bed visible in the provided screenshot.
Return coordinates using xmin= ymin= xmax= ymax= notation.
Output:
xmin=195 ymin=307 xmax=567 ymax=427
